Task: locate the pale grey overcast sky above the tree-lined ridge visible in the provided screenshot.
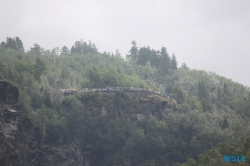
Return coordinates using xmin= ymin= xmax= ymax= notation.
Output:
xmin=0 ymin=0 xmax=250 ymax=86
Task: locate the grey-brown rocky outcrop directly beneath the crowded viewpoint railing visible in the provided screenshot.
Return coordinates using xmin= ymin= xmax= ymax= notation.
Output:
xmin=81 ymin=92 xmax=168 ymax=124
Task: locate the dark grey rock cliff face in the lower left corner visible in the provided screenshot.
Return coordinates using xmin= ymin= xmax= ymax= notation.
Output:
xmin=0 ymin=81 xmax=88 ymax=166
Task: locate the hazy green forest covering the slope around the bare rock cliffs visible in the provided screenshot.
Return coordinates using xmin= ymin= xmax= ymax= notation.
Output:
xmin=0 ymin=37 xmax=250 ymax=166
